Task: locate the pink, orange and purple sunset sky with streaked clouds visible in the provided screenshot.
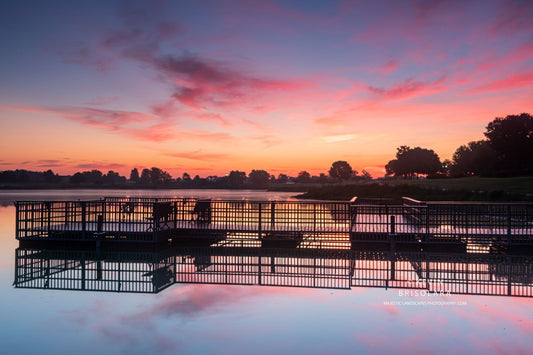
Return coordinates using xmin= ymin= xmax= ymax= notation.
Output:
xmin=0 ymin=0 xmax=533 ymax=177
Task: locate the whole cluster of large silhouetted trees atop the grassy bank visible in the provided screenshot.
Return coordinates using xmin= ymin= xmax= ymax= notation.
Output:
xmin=385 ymin=113 xmax=533 ymax=177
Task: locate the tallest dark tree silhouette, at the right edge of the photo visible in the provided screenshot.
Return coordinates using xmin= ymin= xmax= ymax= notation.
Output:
xmin=485 ymin=113 xmax=533 ymax=173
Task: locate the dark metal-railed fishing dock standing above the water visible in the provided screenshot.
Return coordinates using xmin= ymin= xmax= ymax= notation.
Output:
xmin=16 ymin=198 xmax=533 ymax=253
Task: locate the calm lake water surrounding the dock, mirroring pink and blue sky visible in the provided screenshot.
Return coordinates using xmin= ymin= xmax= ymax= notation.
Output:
xmin=0 ymin=190 xmax=533 ymax=354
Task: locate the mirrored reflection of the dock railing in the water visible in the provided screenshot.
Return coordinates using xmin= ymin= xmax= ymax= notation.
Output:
xmin=14 ymin=247 xmax=533 ymax=301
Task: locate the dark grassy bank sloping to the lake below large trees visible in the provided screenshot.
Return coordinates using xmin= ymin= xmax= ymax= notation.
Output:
xmin=298 ymin=177 xmax=533 ymax=201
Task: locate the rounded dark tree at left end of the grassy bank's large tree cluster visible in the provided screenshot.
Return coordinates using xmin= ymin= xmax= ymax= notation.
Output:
xmin=385 ymin=146 xmax=442 ymax=177
